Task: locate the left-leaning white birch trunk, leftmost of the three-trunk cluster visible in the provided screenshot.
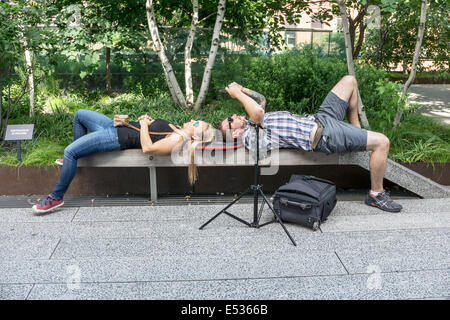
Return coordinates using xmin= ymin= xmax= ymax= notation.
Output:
xmin=145 ymin=0 xmax=187 ymax=109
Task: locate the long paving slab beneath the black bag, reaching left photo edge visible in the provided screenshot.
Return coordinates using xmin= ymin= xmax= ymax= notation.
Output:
xmin=0 ymin=210 xmax=450 ymax=239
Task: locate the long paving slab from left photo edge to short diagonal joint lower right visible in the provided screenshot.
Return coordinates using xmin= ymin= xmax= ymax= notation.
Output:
xmin=0 ymin=251 xmax=346 ymax=284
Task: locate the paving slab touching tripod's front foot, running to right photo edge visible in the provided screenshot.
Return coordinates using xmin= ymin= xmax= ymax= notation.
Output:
xmin=47 ymin=229 xmax=450 ymax=264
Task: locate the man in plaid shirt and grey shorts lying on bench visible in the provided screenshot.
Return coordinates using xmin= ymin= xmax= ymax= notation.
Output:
xmin=219 ymin=76 xmax=402 ymax=212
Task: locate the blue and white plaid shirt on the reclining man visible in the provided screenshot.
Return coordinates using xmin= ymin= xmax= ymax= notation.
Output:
xmin=242 ymin=111 xmax=315 ymax=151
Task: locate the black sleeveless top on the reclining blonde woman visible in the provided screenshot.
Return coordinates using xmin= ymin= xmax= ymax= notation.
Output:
xmin=117 ymin=119 xmax=173 ymax=150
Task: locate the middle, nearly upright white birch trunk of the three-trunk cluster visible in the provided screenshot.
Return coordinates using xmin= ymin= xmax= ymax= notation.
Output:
xmin=184 ymin=0 xmax=198 ymax=108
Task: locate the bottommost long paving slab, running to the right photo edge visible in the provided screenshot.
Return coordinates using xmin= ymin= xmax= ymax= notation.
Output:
xmin=29 ymin=270 xmax=450 ymax=300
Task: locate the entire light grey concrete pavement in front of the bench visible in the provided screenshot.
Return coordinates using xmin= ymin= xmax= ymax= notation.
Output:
xmin=0 ymin=198 xmax=450 ymax=300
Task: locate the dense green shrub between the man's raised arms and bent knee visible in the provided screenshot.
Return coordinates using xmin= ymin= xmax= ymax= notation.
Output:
xmin=236 ymin=49 xmax=346 ymax=113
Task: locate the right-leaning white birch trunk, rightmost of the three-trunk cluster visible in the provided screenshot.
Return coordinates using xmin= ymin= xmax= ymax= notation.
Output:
xmin=194 ymin=0 xmax=226 ymax=111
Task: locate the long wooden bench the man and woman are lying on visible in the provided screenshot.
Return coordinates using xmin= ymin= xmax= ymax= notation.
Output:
xmin=78 ymin=148 xmax=450 ymax=201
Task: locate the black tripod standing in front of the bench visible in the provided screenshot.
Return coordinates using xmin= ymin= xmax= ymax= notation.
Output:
xmin=200 ymin=120 xmax=297 ymax=246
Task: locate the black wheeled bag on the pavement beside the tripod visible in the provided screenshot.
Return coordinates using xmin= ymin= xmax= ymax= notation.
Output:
xmin=273 ymin=174 xmax=336 ymax=231
